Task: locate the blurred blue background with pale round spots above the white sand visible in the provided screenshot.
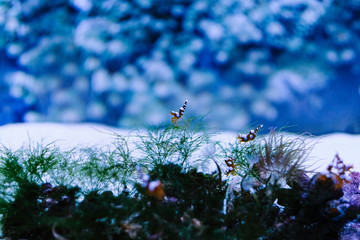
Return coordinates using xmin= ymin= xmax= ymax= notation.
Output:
xmin=0 ymin=0 xmax=360 ymax=134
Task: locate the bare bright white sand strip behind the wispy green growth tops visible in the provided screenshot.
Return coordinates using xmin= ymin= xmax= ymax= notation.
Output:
xmin=0 ymin=123 xmax=360 ymax=171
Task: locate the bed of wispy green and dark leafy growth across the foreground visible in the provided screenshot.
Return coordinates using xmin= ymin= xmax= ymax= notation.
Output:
xmin=0 ymin=121 xmax=360 ymax=240
